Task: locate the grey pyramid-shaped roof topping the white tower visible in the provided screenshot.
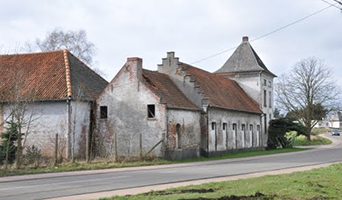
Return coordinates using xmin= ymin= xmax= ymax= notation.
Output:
xmin=214 ymin=37 xmax=276 ymax=77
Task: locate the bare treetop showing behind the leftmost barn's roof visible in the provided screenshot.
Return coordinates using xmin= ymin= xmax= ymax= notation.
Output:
xmin=24 ymin=28 xmax=96 ymax=65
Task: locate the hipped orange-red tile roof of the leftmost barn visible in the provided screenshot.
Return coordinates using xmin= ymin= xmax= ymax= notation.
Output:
xmin=0 ymin=50 xmax=108 ymax=101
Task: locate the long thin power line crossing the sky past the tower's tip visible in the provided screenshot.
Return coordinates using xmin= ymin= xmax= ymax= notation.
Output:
xmin=190 ymin=5 xmax=333 ymax=64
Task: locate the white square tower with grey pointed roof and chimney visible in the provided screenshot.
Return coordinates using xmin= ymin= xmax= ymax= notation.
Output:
xmin=214 ymin=36 xmax=276 ymax=132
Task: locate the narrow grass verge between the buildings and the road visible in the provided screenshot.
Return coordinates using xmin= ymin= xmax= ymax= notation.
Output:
xmin=0 ymin=148 xmax=307 ymax=177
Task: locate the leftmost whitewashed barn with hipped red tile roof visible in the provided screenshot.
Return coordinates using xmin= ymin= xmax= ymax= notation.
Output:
xmin=0 ymin=50 xmax=108 ymax=157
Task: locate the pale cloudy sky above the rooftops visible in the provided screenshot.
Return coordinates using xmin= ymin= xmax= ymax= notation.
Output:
xmin=0 ymin=0 xmax=342 ymax=85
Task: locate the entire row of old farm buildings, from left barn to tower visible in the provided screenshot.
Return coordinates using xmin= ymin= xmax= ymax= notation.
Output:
xmin=0 ymin=37 xmax=275 ymax=160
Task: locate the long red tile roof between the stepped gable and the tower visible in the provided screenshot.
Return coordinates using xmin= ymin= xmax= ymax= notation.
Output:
xmin=180 ymin=63 xmax=262 ymax=113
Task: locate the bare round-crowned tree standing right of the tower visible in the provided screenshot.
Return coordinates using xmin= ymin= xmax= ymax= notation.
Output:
xmin=276 ymin=58 xmax=339 ymax=140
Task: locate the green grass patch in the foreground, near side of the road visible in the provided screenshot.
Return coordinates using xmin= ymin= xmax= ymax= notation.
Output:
xmin=102 ymin=163 xmax=342 ymax=200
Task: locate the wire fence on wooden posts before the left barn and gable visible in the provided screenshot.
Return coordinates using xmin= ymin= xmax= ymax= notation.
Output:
xmin=0 ymin=134 xmax=163 ymax=171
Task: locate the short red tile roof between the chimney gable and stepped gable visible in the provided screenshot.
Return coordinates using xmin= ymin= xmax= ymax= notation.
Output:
xmin=143 ymin=69 xmax=199 ymax=110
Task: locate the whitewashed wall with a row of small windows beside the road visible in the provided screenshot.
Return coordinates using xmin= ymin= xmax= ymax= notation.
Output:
xmin=204 ymin=108 xmax=266 ymax=155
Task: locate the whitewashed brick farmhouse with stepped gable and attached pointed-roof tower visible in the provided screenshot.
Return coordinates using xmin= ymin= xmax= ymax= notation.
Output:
xmin=97 ymin=38 xmax=275 ymax=159
